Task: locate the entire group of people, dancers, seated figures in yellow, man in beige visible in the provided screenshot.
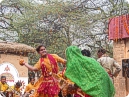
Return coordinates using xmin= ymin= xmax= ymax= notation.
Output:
xmin=0 ymin=45 xmax=121 ymax=97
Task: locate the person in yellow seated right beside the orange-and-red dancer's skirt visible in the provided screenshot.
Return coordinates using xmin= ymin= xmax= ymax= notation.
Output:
xmin=25 ymin=78 xmax=35 ymax=94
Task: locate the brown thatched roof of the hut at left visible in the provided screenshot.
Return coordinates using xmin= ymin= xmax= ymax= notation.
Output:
xmin=0 ymin=40 xmax=35 ymax=54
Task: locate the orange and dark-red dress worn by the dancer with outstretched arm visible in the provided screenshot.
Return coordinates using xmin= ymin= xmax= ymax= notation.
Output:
xmin=34 ymin=54 xmax=65 ymax=97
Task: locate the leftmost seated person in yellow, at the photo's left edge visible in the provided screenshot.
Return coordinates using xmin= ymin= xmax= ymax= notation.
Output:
xmin=0 ymin=76 xmax=9 ymax=92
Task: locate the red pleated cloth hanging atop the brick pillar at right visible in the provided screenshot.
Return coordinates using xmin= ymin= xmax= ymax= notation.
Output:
xmin=108 ymin=15 xmax=129 ymax=40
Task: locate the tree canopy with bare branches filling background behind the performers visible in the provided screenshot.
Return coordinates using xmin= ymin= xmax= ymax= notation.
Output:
xmin=0 ymin=0 xmax=128 ymax=64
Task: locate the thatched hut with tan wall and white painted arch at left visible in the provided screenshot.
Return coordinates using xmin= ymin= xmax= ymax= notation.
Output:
xmin=0 ymin=40 xmax=35 ymax=93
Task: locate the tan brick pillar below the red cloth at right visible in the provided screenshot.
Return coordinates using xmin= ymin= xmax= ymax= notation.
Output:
xmin=113 ymin=40 xmax=128 ymax=97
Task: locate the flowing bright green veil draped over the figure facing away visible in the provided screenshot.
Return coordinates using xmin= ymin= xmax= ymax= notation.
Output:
xmin=65 ymin=46 xmax=115 ymax=97
